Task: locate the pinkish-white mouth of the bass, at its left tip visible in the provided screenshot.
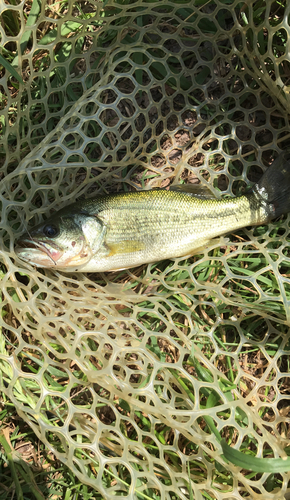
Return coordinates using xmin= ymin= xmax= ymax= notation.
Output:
xmin=15 ymin=239 xmax=63 ymax=267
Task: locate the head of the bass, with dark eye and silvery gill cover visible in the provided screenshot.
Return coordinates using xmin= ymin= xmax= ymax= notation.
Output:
xmin=15 ymin=210 xmax=103 ymax=269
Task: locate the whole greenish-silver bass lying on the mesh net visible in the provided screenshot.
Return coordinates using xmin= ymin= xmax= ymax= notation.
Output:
xmin=15 ymin=152 xmax=290 ymax=272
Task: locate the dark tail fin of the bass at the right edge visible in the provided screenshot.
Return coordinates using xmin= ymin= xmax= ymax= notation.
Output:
xmin=253 ymin=151 xmax=290 ymax=219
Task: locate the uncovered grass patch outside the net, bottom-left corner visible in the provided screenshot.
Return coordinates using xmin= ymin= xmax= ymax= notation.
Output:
xmin=0 ymin=424 xmax=103 ymax=500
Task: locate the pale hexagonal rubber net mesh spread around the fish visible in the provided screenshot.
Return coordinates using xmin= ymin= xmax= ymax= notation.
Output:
xmin=0 ymin=0 xmax=290 ymax=499
